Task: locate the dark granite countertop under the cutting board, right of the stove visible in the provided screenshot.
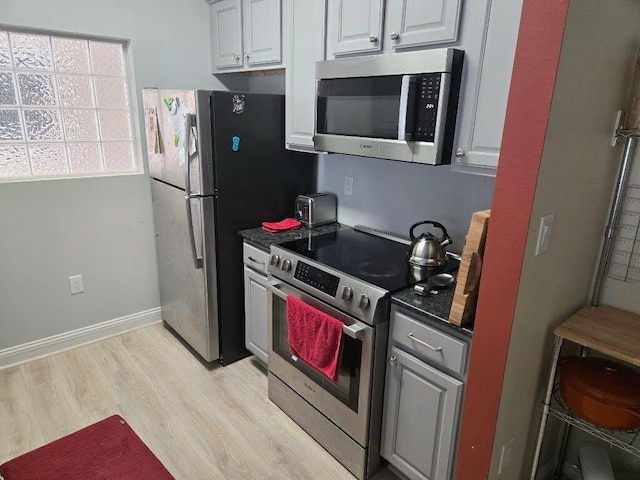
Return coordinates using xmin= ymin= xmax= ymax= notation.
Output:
xmin=391 ymin=286 xmax=473 ymax=338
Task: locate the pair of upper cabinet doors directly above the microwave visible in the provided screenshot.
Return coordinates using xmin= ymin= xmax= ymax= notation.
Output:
xmin=327 ymin=0 xmax=462 ymax=58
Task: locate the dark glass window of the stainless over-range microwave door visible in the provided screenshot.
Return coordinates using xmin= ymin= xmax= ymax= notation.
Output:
xmin=317 ymin=75 xmax=402 ymax=139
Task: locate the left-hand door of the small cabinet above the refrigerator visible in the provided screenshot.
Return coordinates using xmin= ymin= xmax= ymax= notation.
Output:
xmin=209 ymin=0 xmax=243 ymax=72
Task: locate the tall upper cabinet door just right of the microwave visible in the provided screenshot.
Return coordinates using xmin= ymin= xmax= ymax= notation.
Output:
xmin=455 ymin=0 xmax=522 ymax=175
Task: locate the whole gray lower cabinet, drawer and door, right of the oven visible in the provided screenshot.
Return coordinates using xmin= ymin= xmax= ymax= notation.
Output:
xmin=381 ymin=307 xmax=468 ymax=480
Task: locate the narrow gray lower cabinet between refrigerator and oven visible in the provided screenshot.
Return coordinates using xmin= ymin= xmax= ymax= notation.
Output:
xmin=243 ymin=243 xmax=269 ymax=364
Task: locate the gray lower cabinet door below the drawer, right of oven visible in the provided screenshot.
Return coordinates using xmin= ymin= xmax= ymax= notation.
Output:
xmin=382 ymin=347 xmax=462 ymax=480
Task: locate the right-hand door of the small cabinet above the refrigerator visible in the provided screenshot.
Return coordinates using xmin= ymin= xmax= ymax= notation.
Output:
xmin=242 ymin=0 xmax=282 ymax=67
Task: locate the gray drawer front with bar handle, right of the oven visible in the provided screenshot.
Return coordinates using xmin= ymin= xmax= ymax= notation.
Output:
xmin=391 ymin=311 xmax=469 ymax=375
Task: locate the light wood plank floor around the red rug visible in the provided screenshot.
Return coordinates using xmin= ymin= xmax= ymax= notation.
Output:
xmin=0 ymin=324 xmax=400 ymax=480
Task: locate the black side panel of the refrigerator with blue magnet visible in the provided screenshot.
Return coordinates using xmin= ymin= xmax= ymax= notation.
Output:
xmin=211 ymin=92 xmax=316 ymax=365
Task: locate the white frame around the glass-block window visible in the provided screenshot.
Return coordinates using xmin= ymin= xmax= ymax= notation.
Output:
xmin=0 ymin=23 xmax=146 ymax=185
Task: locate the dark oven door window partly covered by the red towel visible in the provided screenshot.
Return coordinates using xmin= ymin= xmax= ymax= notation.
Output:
xmin=272 ymin=296 xmax=362 ymax=412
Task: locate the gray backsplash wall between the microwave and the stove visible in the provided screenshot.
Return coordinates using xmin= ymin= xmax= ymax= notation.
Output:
xmin=318 ymin=154 xmax=494 ymax=253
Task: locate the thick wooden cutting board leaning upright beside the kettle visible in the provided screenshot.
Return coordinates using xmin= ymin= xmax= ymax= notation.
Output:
xmin=449 ymin=210 xmax=491 ymax=326
